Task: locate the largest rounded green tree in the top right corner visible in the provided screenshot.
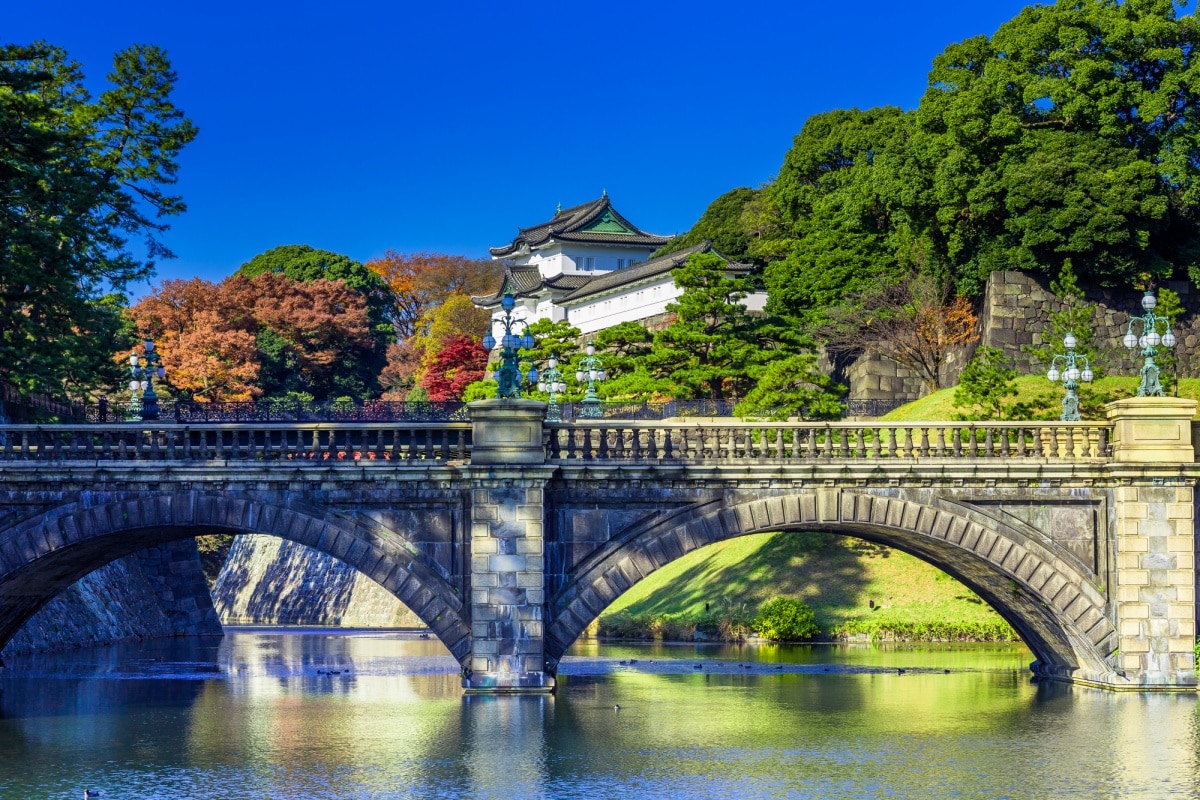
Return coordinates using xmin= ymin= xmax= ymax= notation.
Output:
xmin=911 ymin=0 xmax=1200 ymax=288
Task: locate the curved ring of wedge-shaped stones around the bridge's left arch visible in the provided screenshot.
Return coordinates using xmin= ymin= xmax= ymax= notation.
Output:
xmin=0 ymin=492 xmax=470 ymax=661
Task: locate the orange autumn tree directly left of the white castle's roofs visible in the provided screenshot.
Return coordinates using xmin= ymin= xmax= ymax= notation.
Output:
xmin=365 ymin=249 xmax=503 ymax=341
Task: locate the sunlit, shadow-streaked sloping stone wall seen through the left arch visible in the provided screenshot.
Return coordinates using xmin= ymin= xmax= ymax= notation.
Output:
xmin=212 ymin=534 xmax=425 ymax=627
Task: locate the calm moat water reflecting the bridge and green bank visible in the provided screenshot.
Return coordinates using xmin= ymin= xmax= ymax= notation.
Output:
xmin=0 ymin=628 xmax=1200 ymax=800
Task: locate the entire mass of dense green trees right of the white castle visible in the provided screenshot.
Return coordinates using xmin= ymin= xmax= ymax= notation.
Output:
xmin=662 ymin=0 xmax=1200 ymax=324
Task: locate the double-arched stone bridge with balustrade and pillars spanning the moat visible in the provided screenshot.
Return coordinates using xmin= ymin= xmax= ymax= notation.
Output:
xmin=0 ymin=398 xmax=1200 ymax=692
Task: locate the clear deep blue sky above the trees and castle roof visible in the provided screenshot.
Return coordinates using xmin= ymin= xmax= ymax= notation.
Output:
xmin=9 ymin=0 xmax=1180 ymax=293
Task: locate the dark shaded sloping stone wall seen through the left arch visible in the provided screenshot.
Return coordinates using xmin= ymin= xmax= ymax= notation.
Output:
xmin=0 ymin=539 xmax=221 ymax=658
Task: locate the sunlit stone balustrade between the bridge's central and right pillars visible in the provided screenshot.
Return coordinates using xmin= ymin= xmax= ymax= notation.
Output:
xmin=546 ymin=420 xmax=1111 ymax=463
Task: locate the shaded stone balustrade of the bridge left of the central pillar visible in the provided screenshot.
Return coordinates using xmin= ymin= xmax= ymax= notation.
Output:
xmin=0 ymin=422 xmax=470 ymax=465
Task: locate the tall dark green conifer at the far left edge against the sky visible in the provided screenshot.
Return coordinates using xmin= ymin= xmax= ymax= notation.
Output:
xmin=0 ymin=42 xmax=197 ymax=410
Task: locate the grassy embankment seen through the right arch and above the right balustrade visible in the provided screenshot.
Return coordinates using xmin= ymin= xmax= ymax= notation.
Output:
xmin=598 ymin=375 xmax=1200 ymax=640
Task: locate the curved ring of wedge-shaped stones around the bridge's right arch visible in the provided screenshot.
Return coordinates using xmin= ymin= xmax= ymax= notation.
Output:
xmin=546 ymin=489 xmax=1122 ymax=684
